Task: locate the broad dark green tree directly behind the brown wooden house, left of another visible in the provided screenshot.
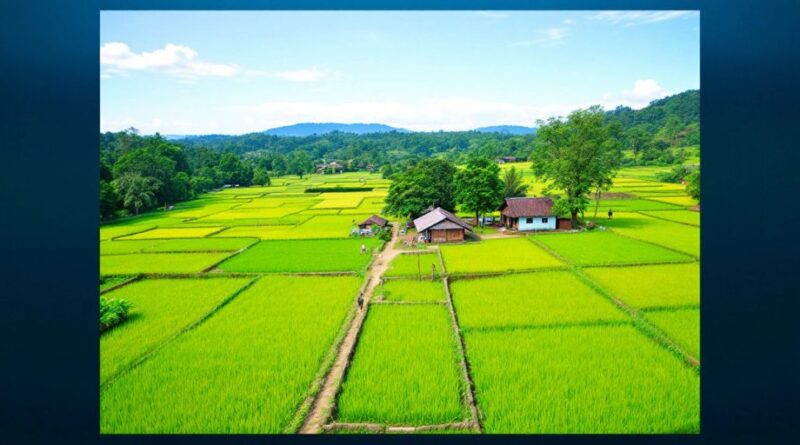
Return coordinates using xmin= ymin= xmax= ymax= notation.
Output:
xmin=384 ymin=159 xmax=456 ymax=218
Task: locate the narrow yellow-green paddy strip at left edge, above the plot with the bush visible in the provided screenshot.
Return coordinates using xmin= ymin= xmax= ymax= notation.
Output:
xmin=100 ymin=253 xmax=230 ymax=275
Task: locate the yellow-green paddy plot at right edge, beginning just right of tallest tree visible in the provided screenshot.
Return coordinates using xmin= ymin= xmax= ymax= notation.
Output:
xmin=603 ymin=213 xmax=700 ymax=257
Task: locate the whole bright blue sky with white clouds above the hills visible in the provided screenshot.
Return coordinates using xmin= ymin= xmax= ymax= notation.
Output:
xmin=99 ymin=11 xmax=700 ymax=135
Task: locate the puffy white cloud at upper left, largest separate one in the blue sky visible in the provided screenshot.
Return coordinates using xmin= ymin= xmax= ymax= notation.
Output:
xmin=100 ymin=42 xmax=238 ymax=78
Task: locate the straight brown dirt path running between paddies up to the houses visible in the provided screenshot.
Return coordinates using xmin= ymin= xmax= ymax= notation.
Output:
xmin=300 ymin=223 xmax=400 ymax=434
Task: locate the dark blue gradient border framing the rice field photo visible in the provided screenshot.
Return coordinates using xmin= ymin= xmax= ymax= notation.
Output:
xmin=0 ymin=0 xmax=800 ymax=444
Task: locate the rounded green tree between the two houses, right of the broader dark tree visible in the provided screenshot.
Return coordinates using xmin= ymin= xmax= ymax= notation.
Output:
xmin=454 ymin=157 xmax=504 ymax=226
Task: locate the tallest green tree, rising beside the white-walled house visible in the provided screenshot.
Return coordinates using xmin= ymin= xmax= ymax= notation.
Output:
xmin=531 ymin=105 xmax=621 ymax=226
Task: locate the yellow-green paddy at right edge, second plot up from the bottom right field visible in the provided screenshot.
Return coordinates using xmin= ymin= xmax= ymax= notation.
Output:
xmin=583 ymin=263 xmax=700 ymax=309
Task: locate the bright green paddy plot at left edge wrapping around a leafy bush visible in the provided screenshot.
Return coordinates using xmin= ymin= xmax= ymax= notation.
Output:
xmin=100 ymin=278 xmax=249 ymax=383
